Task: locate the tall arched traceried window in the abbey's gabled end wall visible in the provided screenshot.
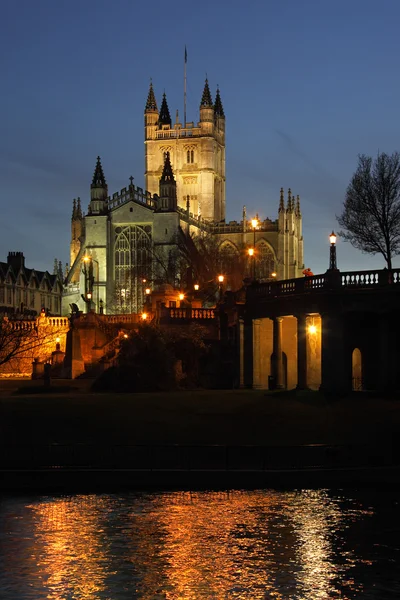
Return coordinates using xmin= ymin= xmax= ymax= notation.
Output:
xmin=116 ymin=225 xmax=152 ymax=313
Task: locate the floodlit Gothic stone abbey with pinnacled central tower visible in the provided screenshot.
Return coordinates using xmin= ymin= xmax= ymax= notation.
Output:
xmin=62 ymin=80 xmax=304 ymax=314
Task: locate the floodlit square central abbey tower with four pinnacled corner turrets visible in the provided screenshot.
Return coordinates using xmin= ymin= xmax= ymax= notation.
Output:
xmin=144 ymin=79 xmax=225 ymax=222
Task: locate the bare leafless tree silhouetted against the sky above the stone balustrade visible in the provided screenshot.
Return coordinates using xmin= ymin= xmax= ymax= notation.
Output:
xmin=337 ymin=152 xmax=400 ymax=269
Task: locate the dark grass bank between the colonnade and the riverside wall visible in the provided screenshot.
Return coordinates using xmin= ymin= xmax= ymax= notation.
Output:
xmin=0 ymin=381 xmax=400 ymax=446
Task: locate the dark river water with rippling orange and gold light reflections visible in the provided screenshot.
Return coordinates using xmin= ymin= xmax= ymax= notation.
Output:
xmin=0 ymin=490 xmax=400 ymax=600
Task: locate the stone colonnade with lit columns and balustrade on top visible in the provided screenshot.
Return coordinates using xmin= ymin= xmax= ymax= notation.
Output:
xmin=237 ymin=269 xmax=400 ymax=393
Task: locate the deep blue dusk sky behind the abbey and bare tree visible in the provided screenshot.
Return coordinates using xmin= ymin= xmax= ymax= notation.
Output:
xmin=0 ymin=0 xmax=400 ymax=273
